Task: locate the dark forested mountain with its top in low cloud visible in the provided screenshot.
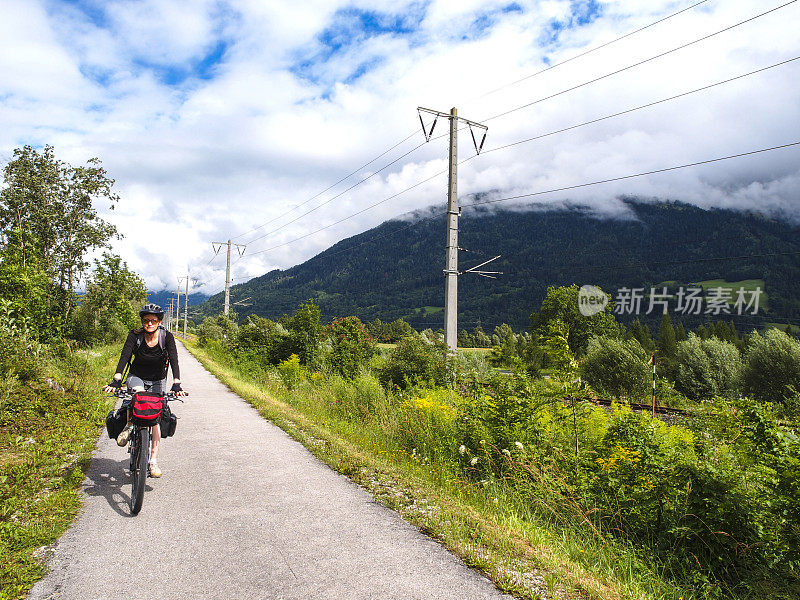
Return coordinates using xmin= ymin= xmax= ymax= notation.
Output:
xmin=199 ymin=199 xmax=800 ymax=330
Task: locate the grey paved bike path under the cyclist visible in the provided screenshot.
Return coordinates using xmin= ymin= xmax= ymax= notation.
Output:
xmin=29 ymin=344 xmax=510 ymax=600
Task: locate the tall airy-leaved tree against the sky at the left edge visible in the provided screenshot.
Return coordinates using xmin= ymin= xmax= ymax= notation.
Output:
xmin=0 ymin=146 xmax=119 ymax=317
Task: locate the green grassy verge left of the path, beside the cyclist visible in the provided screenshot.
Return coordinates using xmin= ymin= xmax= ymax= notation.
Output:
xmin=0 ymin=347 xmax=119 ymax=600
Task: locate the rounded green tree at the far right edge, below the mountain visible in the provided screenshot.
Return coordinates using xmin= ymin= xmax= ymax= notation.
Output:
xmin=742 ymin=329 xmax=800 ymax=403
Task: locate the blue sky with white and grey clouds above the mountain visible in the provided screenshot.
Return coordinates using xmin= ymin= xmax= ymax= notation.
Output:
xmin=0 ymin=0 xmax=800 ymax=293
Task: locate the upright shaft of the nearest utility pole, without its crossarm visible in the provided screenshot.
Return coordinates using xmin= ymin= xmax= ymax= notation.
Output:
xmin=444 ymin=108 xmax=459 ymax=352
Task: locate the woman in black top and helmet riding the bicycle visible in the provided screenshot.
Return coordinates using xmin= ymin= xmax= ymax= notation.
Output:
xmin=103 ymin=304 xmax=187 ymax=477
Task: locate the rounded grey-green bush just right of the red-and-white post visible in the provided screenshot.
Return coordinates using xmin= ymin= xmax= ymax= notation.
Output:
xmin=675 ymin=333 xmax=742 ymax=400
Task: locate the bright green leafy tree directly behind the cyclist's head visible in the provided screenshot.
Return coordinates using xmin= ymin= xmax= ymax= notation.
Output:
xmin=70 ymin=252 xmax=147 ymax=344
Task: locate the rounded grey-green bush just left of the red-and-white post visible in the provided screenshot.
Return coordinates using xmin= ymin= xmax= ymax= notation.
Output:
xmin=582 ymin=336 xmax=652 ymax=398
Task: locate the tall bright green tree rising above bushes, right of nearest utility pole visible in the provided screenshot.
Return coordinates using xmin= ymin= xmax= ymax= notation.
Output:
xmin=531 ymin=284 xmax=619 ymax=356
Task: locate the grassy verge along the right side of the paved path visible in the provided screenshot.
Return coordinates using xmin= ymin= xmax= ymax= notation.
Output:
xmin=187 ymin=344 xmax=698 ymax=600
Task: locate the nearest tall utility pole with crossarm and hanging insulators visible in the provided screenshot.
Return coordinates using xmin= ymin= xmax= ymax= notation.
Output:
xmin=417 ymin=107 xmax=488 ymax=352
